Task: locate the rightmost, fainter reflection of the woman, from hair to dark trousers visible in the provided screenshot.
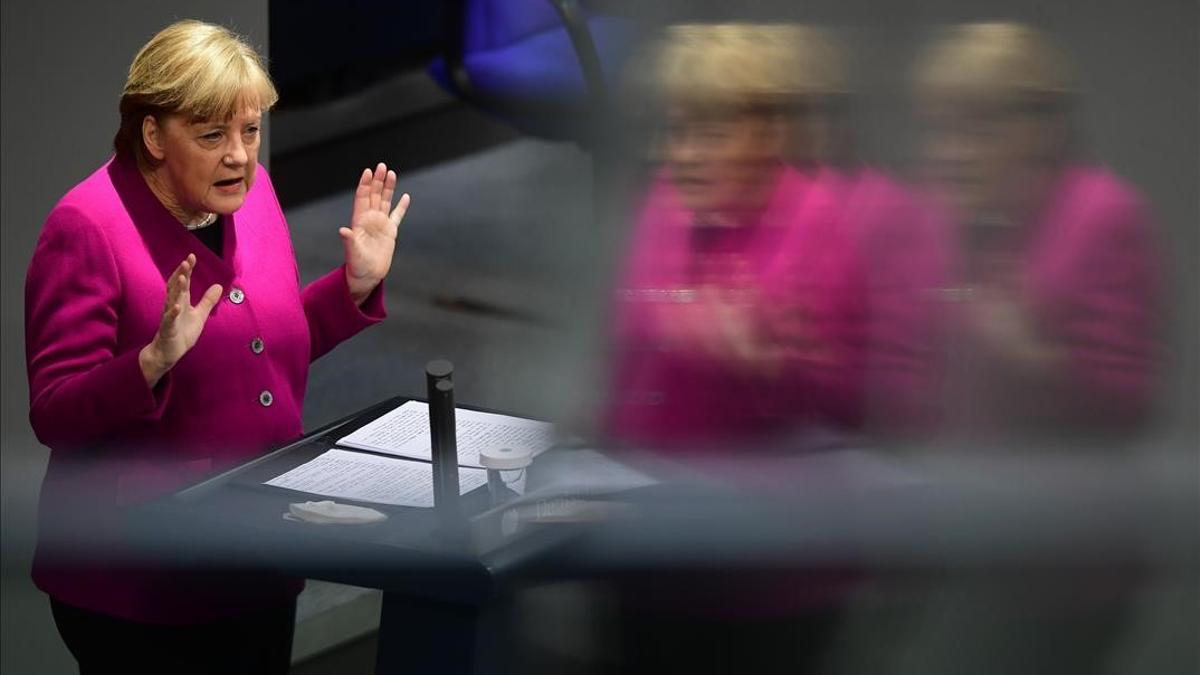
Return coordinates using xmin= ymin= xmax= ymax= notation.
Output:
xmin=913 ymin=23 xmax=1159 ymax=673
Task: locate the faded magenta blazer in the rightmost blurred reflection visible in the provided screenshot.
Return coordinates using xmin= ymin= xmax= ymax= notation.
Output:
xmin=864 ymin=165 xmax=1163 ymax=436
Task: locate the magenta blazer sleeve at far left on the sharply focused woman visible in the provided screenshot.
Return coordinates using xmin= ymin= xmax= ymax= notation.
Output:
xmin=25 ymin=205 xmax=172 ymax=450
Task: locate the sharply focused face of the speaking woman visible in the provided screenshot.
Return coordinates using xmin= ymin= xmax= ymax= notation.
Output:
xmin=146 ymin=108 xmax=263 ymax=215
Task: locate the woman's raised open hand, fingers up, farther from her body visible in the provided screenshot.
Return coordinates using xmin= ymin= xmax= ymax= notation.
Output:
xmin=337 ymin=162 xmax=409 ymax=305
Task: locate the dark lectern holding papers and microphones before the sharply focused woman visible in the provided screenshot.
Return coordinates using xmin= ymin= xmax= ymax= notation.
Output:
xmin=130 ymin=398 xmax=583 ymax=675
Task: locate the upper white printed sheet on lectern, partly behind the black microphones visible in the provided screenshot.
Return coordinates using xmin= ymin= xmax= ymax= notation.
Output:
xmin=337 ymin=401 xmax=554 ymax=467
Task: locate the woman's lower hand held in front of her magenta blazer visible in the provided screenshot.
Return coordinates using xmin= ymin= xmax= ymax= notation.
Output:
xmin=138 ymin=253 xmax=222 ymax=389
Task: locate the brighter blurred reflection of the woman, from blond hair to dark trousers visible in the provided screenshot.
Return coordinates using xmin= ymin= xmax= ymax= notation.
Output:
xmin=606 ymin=24 xmax=865 ymax=673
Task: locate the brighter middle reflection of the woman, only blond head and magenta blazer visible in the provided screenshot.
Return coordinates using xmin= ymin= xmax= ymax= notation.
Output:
xmin=607 ymin=25 xmax=862 ymax=449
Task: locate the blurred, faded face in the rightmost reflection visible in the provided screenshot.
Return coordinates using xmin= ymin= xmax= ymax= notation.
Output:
xmin=923 ymin=97 xmax=1063 ymax=217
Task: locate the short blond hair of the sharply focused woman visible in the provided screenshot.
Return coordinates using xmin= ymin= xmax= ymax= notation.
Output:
xmin=113 ymin=19 xmax=278 ymax=166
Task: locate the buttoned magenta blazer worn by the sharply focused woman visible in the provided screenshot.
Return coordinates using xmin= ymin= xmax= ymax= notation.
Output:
xmin=25 ymin=159 xmax=385 ymax=623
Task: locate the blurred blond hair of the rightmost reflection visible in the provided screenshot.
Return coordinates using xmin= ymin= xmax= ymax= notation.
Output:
xmin=916 ymin=23 xmax=1076 ymax=104
